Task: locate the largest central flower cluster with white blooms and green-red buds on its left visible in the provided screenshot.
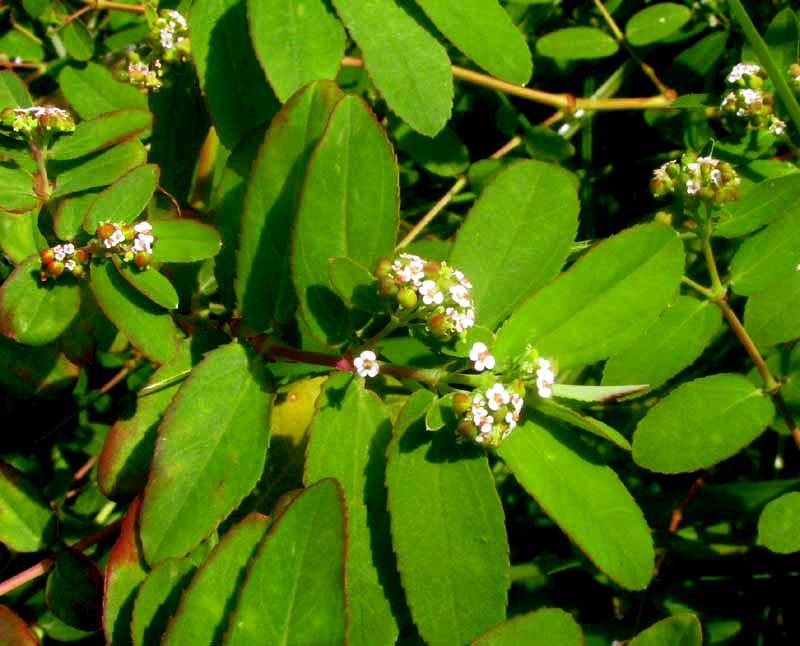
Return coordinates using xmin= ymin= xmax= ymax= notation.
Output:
xmin=375 ymin=253 xmax=475 ymax=341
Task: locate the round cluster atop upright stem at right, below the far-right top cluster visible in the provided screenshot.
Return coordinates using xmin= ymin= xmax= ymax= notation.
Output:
xmin=650 ymin=152 xmax=740 ymax=204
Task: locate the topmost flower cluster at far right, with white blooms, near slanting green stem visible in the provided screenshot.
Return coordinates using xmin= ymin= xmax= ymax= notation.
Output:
xmin=719 ymin=63 xmax=786 ymax=135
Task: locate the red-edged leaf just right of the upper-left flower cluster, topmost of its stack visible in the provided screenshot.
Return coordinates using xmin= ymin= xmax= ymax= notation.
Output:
xmin=47 ymin=108 xmax=153 ymax=159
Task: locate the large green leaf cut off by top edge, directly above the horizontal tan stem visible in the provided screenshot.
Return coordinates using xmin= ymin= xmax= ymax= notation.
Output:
xmin=417 ymin=0 xmax=533 ymax=85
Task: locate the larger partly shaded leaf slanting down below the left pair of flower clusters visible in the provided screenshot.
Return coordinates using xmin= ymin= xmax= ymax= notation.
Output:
xmin=90 ymin=262 xmax=176 ymax=363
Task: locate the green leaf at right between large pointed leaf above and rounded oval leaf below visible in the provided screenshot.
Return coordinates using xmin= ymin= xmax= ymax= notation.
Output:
xmin=602 ymin=296 xmax=722 ymax=390
